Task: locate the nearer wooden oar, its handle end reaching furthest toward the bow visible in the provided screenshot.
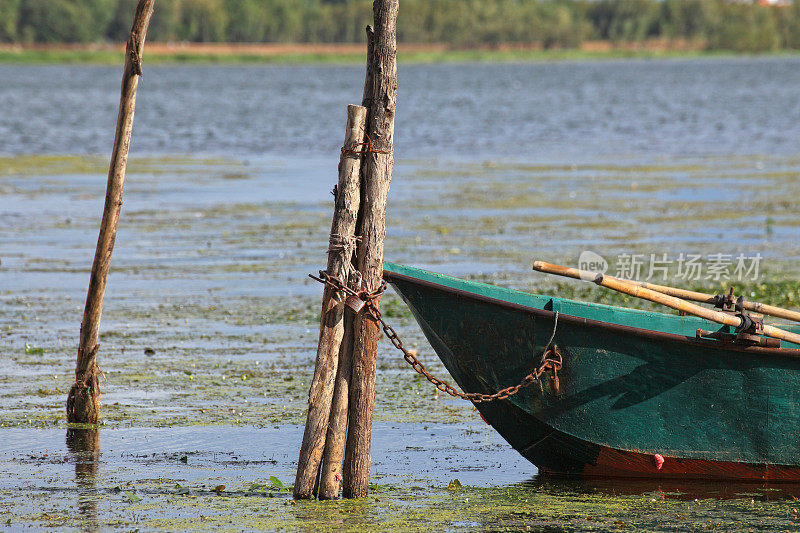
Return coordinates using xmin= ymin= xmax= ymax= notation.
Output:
xmin=533 ymin=261 xmax=800 ymax=344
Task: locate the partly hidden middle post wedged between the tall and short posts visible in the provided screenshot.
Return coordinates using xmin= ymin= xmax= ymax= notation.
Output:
xmin=318 ymin=26 xmax=375 ymax=500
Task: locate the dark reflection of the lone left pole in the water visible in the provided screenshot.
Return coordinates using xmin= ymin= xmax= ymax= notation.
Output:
xmin=67 ymin=428 xmax=100 ymax=531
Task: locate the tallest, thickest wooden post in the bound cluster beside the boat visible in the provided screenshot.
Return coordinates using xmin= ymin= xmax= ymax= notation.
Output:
xmin=342 ymin=0 xmax=399 ymax=498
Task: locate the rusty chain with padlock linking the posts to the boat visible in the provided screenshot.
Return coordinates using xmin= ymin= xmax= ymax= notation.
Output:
xmin=309 ymin=270 xmax=563 ymax=403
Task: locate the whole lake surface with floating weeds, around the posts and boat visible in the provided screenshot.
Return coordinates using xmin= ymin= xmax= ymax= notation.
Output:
xmin=0 ymin=58 xmax=800 ymax=530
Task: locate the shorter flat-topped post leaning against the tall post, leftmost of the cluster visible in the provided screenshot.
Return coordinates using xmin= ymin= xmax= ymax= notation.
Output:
xmin=294 ymin=105 xmax=367 ymax=498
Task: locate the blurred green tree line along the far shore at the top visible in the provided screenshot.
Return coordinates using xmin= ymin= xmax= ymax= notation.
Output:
xmin=0 ymin=0 xmax=800 ymax=51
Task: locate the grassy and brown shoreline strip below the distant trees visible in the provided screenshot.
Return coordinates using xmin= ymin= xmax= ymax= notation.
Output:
xmin=0 ymin=40 xmax=800 ymax=65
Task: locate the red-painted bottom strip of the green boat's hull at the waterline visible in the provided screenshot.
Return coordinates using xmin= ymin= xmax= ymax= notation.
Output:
xmin=543 ymin=447 xmax=800 ymax=483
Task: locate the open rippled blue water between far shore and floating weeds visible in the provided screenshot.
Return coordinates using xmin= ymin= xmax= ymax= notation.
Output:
xmin=0 ymin=58 xmax=800 ymax=162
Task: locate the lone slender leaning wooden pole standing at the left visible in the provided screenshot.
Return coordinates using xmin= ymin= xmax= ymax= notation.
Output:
xmin=67 ymin=0 xmax=155 ymax=424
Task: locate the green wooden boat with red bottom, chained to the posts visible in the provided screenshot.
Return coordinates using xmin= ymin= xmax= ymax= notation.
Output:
xmin=384 ymin=263 xmax=800 ymax=481
